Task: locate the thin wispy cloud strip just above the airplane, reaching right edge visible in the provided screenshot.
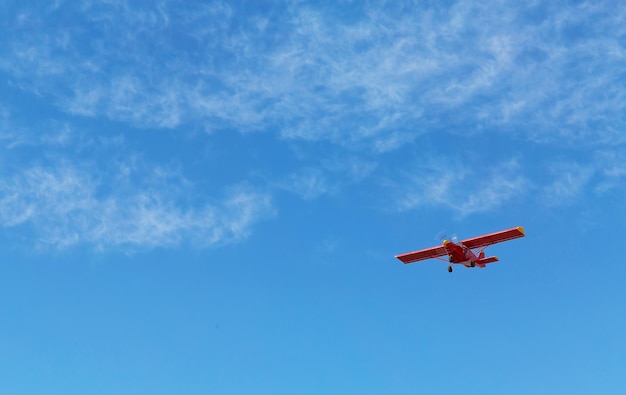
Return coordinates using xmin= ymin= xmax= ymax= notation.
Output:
xmin=390 ymin=150 xmax=626 ymax=217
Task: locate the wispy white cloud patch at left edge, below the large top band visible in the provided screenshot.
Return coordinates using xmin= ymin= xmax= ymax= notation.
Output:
xmin=0 ymin=165 xmax=273 ymax=248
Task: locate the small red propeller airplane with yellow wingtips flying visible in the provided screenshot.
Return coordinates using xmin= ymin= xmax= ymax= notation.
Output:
xmin=396 ymin=226 xmax=525 ymax=272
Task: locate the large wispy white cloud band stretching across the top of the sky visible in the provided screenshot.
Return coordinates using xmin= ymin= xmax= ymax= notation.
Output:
xmin=0 ymin=1 xmax=626 ymax=147
